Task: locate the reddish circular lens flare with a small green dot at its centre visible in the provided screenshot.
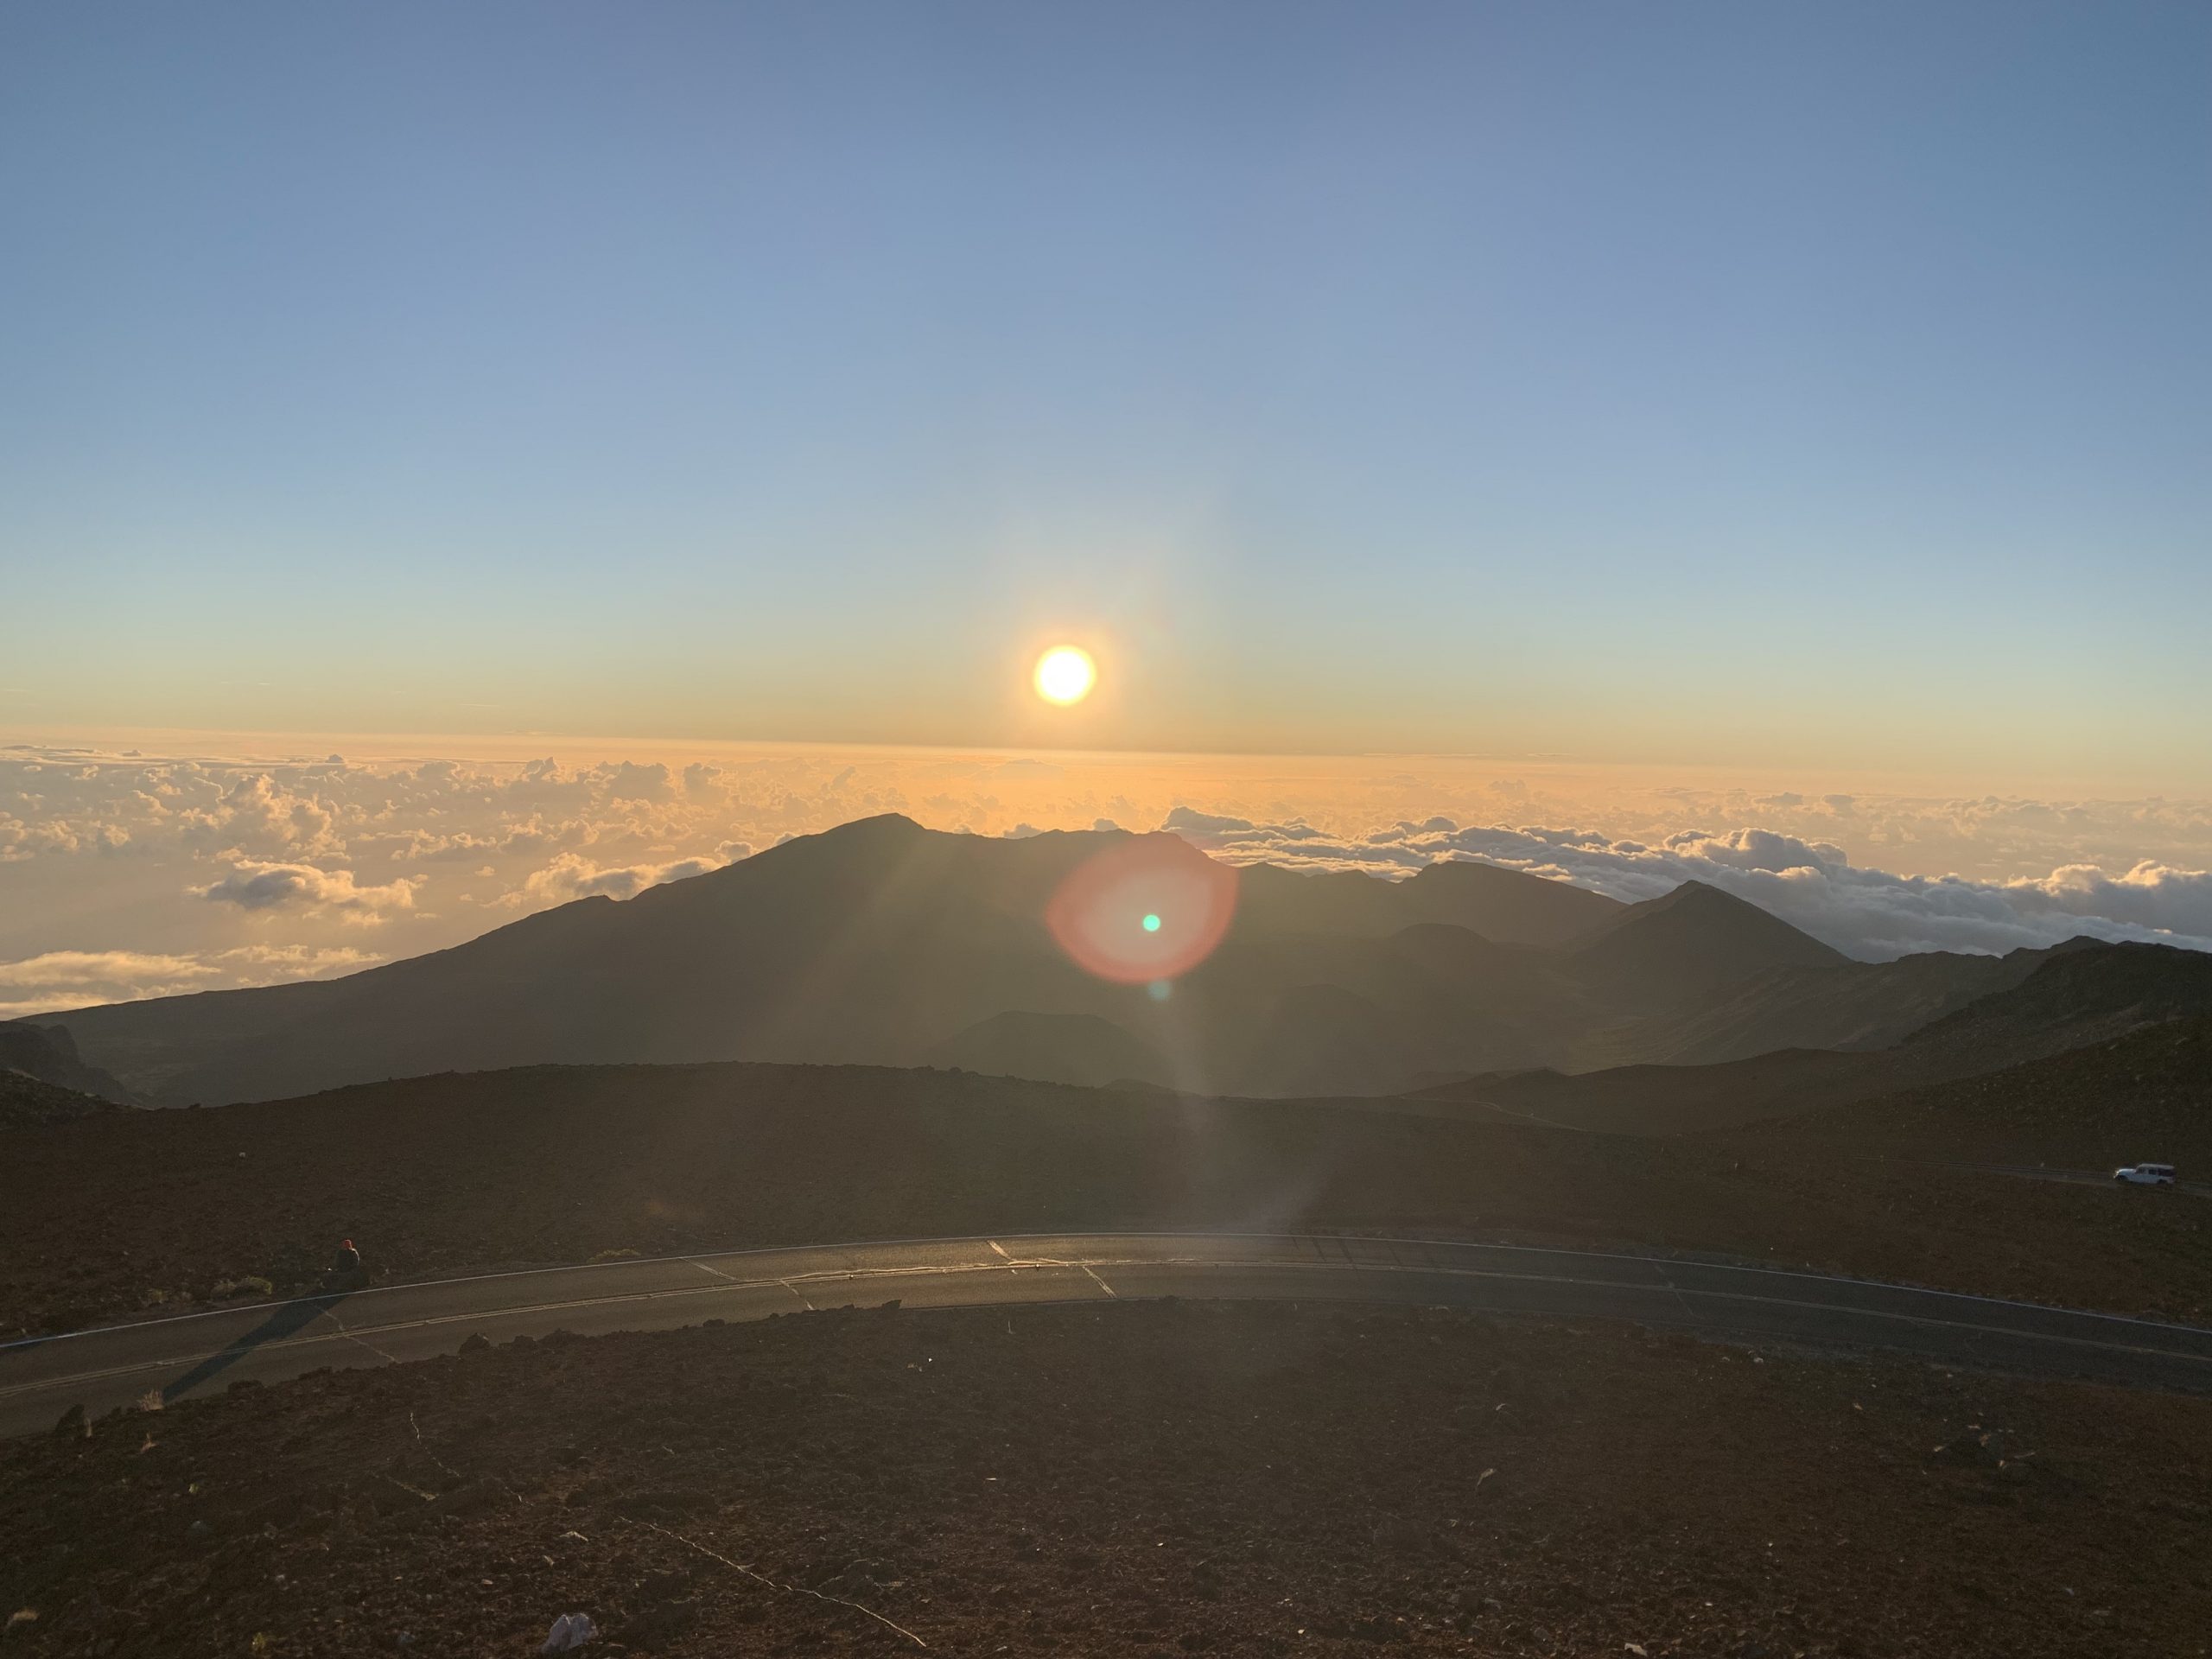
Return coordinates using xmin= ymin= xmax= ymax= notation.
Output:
xmin=1044 ymin=836 xmax=1236 ymax=984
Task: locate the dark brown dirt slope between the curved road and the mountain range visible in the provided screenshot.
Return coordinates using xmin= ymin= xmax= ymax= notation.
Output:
xmin=0 ymin=1066 xmax=2212 ymax=1334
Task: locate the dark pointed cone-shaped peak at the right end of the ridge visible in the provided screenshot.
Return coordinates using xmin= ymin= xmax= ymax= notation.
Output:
xmin=1571 ymin=880 xmax=1852 ymax=1013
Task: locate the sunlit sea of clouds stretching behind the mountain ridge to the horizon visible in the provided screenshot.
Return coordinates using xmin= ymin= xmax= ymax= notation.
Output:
xmin=0 ymin=746 xmax=2212 ymax=1018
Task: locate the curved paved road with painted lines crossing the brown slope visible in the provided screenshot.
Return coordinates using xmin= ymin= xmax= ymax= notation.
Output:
xmin=0 ymin=1232 xmax=2212 ymax=1433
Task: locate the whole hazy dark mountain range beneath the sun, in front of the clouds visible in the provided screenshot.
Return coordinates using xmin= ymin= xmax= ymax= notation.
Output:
xmin=35 ymin=817 xmax=2212 ymax=1115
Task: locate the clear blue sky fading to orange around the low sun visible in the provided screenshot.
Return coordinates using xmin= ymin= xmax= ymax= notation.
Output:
xmin=0 ymin=4 xmax=2212 ymax=790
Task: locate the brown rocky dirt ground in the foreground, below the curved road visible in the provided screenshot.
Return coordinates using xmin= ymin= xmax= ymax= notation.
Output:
xmin=0 ymin=1303 xmax=2212 ymax=1659
